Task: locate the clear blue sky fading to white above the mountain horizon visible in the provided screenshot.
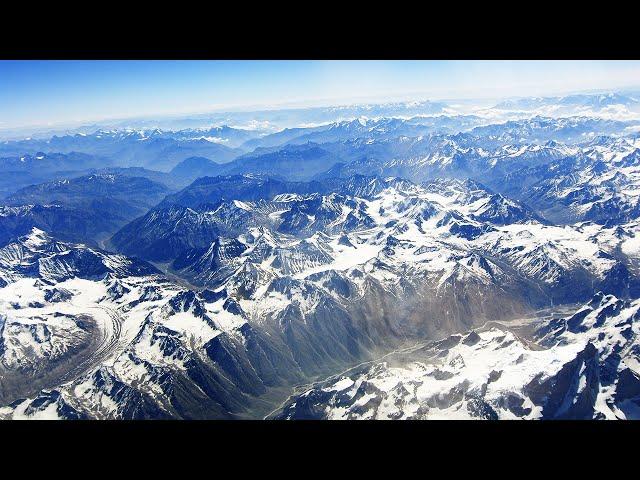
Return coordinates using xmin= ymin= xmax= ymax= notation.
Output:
xmin=0 ymin=61 xmax=640 ymax=129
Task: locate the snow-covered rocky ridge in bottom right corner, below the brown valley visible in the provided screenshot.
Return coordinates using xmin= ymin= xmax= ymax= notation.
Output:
xmin=265 ymin=295 xmax=640 ymax=419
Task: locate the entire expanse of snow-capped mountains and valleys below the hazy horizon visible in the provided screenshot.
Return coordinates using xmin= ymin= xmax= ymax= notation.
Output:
xmin=0 ymin=95 xmax=640 ymax=419
